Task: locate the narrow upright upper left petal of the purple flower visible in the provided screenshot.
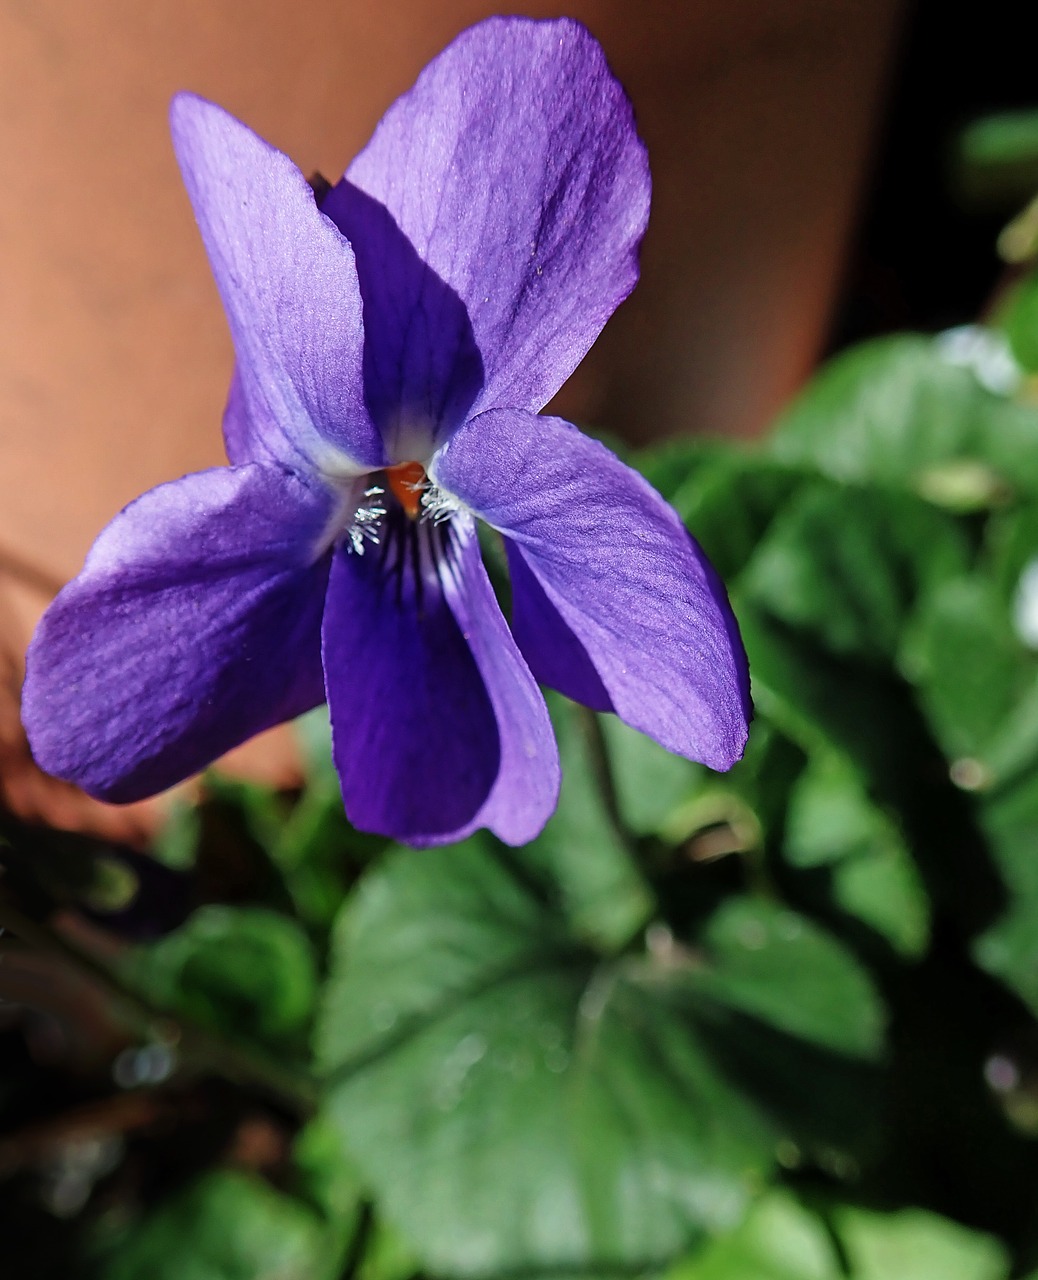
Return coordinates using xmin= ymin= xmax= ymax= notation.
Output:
xmin=170 ymin=93 xmax=385 ymax=471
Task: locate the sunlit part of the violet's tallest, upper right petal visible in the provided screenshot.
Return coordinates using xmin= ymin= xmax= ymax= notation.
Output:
xmin=323 ymin=18 xmax=649 ymax=413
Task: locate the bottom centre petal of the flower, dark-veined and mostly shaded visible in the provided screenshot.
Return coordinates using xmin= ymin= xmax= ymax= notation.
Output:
xmin=324 ymin=517 xmax=559 ymax=845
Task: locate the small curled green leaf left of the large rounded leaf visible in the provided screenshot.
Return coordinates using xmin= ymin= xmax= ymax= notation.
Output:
xmin=131 ymin=906 xmax=317 ymax=1047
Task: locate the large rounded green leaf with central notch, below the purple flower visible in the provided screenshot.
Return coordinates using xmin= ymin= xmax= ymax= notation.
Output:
xmin=317 ymin=841 xmax=882 ymax=1275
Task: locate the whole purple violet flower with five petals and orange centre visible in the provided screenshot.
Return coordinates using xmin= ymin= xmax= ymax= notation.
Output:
xmin=23 ymin=18 xmax=749 ymax=845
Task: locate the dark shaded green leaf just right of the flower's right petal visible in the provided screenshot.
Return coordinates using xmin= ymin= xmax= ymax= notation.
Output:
xmin=739 ymin=481 xmax=969 ymax=660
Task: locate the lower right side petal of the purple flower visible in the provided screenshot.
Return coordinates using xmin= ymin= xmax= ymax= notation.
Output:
xmin=430 ymin=410 xmax=750 ymax=769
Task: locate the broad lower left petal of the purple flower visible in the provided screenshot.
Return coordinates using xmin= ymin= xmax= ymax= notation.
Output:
xmin=22 ymin=463 xmax=331 ymax=801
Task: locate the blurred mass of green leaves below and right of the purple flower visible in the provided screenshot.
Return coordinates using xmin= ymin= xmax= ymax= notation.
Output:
xmin=8 ymin=215 xmax=1038 ymax=1280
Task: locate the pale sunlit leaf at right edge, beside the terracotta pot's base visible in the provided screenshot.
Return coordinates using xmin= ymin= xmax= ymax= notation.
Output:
xmin=771 ymin=337 xmax=1038 ymax=502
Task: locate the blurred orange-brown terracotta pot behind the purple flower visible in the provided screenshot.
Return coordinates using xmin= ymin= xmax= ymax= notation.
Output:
xmin=0 ymin=0 xmax=901 ymax=819
